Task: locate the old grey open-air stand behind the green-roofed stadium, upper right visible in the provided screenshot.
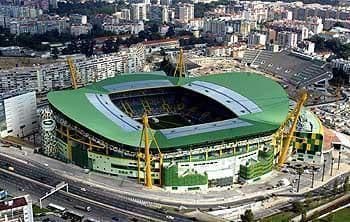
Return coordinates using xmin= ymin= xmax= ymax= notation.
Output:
xmin=242 ymin=50 xmax=332 ymax=87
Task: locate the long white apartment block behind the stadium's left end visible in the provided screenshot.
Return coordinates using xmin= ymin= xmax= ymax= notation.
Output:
xmin=0 ymin=43 xmax=145 ymax=119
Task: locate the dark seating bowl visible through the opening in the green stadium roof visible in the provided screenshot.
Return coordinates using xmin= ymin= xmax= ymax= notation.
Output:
xmin=110 ymin=87 xmax=234 ymax=128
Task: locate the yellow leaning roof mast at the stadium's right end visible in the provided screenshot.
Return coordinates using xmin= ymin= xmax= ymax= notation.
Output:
xmin=277 ymin=91 xmax=307 ymax=167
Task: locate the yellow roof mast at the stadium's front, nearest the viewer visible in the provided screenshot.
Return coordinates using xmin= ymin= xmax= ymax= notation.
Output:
xmin=137 ymin=113 xmax=163 ymax=189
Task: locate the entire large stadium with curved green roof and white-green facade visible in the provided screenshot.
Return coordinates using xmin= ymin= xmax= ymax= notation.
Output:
xmin=41 ymin=72 xmax=322 ymax=191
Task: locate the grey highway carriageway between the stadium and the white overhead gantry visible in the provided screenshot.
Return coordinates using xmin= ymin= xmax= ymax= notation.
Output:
xmin=0 ymin=155 xmax=191 ymax=221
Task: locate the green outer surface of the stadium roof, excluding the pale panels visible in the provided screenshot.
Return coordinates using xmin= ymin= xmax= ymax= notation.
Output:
xmin=48 ymin=72 xmax=289 ymax=149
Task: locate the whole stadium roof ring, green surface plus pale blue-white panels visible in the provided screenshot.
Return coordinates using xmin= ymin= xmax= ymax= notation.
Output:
xmin=48 ymin=72 xmax=289 ymax=149
